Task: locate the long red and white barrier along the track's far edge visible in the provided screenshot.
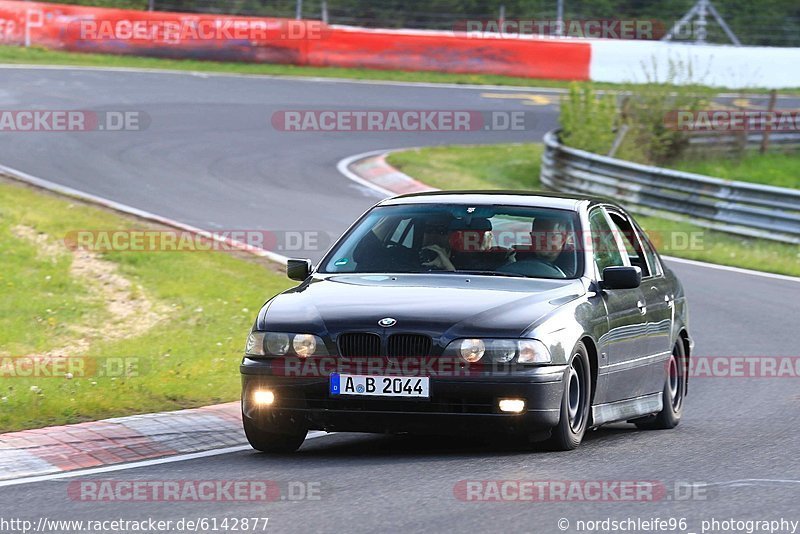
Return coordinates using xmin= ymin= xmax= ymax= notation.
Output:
xmin=0 ymin=0 xmax=800 ymax=88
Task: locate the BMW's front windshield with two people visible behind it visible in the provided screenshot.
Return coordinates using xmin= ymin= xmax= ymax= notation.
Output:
xmin=320 ymin=204 xmax=582 ymax=278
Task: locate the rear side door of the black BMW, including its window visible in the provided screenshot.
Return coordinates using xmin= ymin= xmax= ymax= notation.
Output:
xmin=608 ymin=208 xmax=674 ymax=393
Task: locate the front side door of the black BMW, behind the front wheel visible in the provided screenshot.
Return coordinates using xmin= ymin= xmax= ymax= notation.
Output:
xmin=589 ymin=206 xmax=652 ymax=403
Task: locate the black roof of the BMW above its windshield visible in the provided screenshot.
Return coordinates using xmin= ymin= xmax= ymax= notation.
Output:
xmin=378 ymin=190 xmax=619 ymax=211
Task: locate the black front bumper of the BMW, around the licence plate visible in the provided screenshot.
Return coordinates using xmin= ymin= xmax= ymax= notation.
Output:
xmin=240 ymin=359 xmax=566 ymax=440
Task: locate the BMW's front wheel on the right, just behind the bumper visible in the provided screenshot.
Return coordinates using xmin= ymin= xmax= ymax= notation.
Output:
xmin=548 ymin=342 xmax=592 ymax=451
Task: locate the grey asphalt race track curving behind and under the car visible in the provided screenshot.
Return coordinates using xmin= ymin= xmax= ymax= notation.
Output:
xmin=0 ymin=68 xmax=800 ymax=533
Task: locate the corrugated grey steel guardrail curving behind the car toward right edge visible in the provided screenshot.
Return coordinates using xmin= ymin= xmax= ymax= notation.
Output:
xmin=541 ymin=130 xmax=800 ymax=244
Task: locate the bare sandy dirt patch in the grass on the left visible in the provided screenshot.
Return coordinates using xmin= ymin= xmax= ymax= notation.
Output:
xmin=11 ymin=225 xmax=167 ymax=356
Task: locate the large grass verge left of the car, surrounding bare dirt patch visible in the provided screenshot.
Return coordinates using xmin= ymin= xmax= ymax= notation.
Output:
xmin=0 ymin=183 xmax=290 ymax=432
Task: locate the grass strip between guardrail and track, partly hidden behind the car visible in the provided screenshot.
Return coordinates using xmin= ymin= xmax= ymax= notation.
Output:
xmin=388 ymin=143 xmax=800 ymax=276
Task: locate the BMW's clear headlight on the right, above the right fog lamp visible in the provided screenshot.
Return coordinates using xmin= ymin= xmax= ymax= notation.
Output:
xmin=445 ymin=338 xmax=552 ymax=363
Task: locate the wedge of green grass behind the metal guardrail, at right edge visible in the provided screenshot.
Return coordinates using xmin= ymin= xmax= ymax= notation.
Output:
xmin=675 ymin=152 xmax=800 ymax=189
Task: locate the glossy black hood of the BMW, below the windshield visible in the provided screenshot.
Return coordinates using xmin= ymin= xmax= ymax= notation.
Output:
xmin=257 ymin=273 xmax=585 ymax=338
